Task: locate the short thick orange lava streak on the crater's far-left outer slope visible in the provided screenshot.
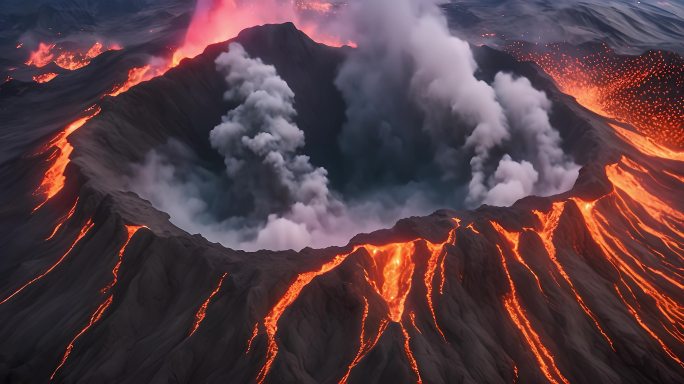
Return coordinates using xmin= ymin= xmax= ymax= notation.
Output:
xmin=33 ymin=107 xmax=100 ymax=212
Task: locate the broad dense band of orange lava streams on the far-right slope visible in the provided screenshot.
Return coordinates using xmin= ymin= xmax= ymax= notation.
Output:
xmin=572 ymin=156 xmax=684 ymax=367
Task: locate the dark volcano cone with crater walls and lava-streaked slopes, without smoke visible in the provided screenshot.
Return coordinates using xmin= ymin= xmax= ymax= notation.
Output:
xmin=0 ymin=24 xmax=684 ymax=383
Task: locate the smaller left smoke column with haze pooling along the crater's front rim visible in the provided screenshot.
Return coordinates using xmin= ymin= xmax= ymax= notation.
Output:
xmin=129 ymin=43 xmax=424 ymax=250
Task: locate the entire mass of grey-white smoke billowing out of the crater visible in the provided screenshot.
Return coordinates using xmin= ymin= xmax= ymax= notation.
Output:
xmin=130 ymin=0 xmax=579 ymax=250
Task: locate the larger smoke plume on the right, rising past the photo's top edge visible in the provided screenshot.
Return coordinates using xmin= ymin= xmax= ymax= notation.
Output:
xmin=337 ymin=0 xmax=578 ymax=206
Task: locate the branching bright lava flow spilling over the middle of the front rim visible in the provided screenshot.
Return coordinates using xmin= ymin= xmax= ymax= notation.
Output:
xmin=248 ymin=226 xmax=458 ymax=383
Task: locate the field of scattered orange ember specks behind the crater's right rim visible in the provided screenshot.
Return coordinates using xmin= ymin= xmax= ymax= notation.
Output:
xmin=510 ymin=43 xmax=684 ymax=149
